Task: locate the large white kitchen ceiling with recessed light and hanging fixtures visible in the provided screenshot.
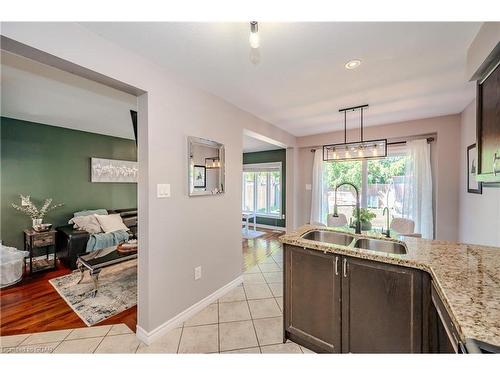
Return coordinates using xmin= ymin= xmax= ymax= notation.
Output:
xmin=82 ymin=22 xmax=480 ymax=136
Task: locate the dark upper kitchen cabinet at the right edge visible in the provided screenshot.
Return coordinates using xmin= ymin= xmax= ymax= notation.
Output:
xmin=477 ymin=58 xmax=500 ymax=182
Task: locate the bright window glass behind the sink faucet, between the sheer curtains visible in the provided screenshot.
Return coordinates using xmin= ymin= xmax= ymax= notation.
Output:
xmin=324 ymin=150 xmax=407 ymax=228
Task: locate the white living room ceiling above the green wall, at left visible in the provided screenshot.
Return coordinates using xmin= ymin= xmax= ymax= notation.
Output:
xmin=1 ymin=51 xmax=137 ymax=139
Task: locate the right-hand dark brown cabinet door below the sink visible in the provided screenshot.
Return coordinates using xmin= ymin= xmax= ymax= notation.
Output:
xmin=342 ymin=257 xmax=422 ymax=353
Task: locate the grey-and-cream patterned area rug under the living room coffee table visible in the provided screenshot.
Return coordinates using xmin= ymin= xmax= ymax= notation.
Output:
xmin=49 ymin=259 xmax=137 ymax=327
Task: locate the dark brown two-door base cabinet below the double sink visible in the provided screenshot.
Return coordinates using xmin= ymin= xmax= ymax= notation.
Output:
xmin=283 ymin=245 xmax=428 ymax=353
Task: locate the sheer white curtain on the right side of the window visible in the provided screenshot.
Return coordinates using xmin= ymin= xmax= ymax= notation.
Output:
xmin=402 ymin=139 xmax=434 ymax=239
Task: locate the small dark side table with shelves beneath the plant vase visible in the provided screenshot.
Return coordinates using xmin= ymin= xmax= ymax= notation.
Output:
xmin=24 ymin=228 xmax=57 ymax=274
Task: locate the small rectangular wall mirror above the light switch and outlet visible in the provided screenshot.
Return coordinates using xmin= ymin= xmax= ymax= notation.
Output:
xmin=188 ymin=137 xmax=226 ymax=197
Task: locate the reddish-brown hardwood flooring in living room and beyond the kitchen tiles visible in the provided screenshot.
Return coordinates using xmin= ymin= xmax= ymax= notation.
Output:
xmin=0 ymin=229 xmax=283 ymax=336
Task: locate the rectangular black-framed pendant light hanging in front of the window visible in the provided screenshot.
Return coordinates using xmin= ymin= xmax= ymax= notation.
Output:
xmin=323 ymin=104 xmax=387 ymax=161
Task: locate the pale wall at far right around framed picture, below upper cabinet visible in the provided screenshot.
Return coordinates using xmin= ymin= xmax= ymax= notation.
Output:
xmin=458 ymin=100 xmax=500 ymax=246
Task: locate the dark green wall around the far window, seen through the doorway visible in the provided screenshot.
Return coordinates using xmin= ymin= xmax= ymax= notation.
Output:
xmin=243 ymin=149 xmax=286 ymax=228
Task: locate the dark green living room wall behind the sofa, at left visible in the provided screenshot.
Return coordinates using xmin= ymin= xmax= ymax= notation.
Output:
xmin=0 ymin=117 xmax=137 ymax=253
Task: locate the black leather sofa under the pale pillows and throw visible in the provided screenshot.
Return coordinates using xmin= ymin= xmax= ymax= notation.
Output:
xmin=56 ymin=208 xmax=137 ymax=270
